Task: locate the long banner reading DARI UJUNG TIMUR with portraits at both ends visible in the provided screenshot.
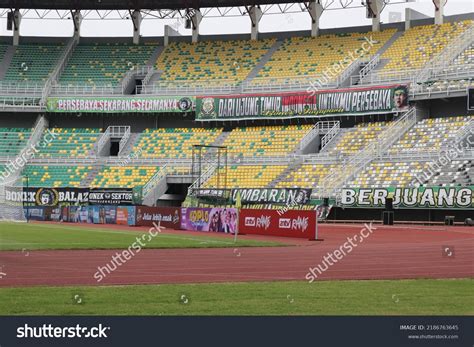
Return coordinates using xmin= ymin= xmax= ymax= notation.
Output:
xmin=196 ymin=85 xmax=408 ymax=121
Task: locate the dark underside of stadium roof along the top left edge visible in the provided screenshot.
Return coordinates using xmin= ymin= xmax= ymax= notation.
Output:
xmin=0 ymin=0 xmax=304 ymax=10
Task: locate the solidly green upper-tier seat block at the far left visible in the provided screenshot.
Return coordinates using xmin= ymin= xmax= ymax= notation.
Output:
xmin=3 ymin=44 xmax=64 ymax=83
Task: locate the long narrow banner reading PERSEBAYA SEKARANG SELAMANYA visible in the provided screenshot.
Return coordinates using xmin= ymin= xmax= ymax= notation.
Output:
xmin=46 ymin=96 xmax=196 ymax=113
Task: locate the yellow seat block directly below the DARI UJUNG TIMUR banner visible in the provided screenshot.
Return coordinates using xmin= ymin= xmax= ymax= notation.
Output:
xmin=223 ymin=125 xmax=311 ymax=156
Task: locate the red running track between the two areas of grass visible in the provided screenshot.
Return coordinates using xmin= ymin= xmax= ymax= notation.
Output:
xmin=0 ymin=225 xmax=474 ymax=287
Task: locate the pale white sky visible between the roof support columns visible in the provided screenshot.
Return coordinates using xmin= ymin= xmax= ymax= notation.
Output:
xmin=0 ymin=0 xmax=474 ymax=37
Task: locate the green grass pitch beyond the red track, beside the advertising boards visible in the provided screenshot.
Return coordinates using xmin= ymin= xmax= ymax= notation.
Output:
xmin=0 ymin=223 xmax=284 ymax=251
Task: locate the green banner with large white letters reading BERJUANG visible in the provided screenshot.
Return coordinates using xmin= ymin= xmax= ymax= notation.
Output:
xmin=341 ymin=186 xmax=474 ymax=209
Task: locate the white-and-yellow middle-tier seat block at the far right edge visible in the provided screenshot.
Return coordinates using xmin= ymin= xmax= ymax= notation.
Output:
xmin=391 ymin=116 xmax=472 ymax=153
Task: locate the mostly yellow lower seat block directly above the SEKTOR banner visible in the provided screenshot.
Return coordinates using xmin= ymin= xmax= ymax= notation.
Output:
xmin=91 ymin=166 xmax=159 ymax=188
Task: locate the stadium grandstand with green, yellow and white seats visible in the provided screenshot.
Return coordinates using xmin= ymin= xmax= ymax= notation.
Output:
xmin=0 ymin=0 xmax=474 ymax=226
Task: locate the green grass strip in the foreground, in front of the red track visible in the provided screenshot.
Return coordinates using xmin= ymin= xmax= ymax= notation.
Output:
xmin=0 ymin=279 xmax=474 ymax=315
